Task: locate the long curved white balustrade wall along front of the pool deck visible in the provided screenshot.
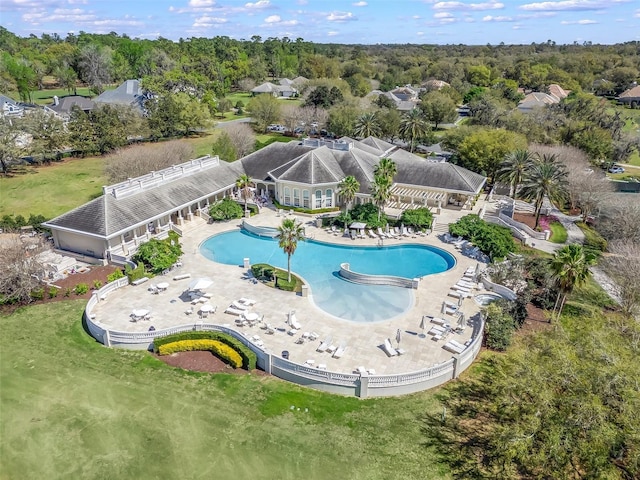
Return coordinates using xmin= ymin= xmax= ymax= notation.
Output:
xmin=85 ymin=277 xmax=484 ymax=398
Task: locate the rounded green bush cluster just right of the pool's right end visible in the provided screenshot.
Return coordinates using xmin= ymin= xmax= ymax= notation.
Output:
xmin=449 ymin=214 xmax=516 ymax=260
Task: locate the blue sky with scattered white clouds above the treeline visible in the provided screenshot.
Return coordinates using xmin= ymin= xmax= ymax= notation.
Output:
xmin=0 ymin=0 xmax=640 ymax=45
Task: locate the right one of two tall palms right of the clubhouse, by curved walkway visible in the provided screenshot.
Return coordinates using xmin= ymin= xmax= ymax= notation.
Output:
xmin=520 ymin=155 xmax=569 ymax=227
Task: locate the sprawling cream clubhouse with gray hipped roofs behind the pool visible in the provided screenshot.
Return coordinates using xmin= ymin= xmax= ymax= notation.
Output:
xmin=44 ymin=137 xmax=486 ymax=263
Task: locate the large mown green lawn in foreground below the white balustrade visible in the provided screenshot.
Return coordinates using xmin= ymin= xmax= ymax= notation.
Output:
xmin=0 ymin=300 xmax=450 ymax=480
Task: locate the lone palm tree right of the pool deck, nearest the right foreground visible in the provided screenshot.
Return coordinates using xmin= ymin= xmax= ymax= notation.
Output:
xmin=551 ymin=243 xmax=596 ymax=318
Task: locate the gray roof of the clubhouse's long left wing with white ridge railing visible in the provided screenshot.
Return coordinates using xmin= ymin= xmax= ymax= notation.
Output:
xmin=46 ymin=162 xmax=242 ymax=238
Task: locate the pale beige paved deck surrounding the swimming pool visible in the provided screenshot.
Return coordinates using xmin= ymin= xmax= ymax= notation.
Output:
xmin=93 ymin=208 xmax=484 ymax=374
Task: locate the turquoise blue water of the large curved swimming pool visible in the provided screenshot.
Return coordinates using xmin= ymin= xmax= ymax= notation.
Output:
xmin=200 ymin=230 xmax=455 ymax=322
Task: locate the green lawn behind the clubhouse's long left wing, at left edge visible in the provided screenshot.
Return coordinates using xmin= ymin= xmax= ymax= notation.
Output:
xmin=0 ymin=157 xmax=106 ymax=218
